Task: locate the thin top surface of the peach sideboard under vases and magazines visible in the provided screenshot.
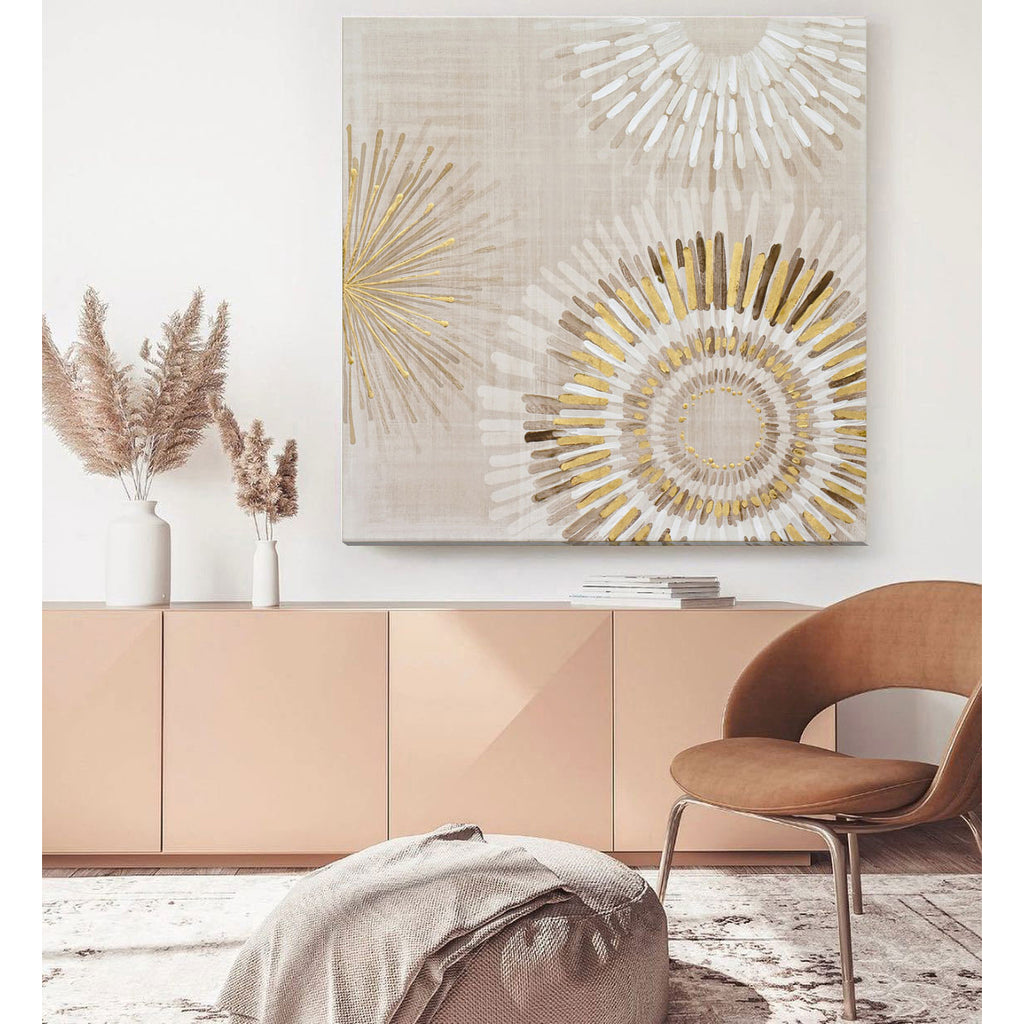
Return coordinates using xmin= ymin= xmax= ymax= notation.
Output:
xmin=43 ymin=601 xmax=816 ymax=613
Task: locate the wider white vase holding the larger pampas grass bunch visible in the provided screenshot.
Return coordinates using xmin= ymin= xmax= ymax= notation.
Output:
xmin=106 ymin=502 xmax=171 ymax=608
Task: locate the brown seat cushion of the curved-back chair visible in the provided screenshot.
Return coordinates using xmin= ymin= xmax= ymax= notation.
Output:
xmin=671 ymin=736 xmax=936 ymax=814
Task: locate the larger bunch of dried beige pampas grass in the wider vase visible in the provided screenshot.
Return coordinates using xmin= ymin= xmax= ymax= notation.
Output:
xmin=43 ymin=288 xmax=228 ymax=499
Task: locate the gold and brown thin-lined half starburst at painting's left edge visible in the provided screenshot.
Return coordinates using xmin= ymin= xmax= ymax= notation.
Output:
xmin=342 ymin=125 xmax=498 ymax=443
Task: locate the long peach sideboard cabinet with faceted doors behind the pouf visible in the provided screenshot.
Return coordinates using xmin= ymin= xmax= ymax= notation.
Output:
xmin=43 ymin=604 xmax=836 ymax=866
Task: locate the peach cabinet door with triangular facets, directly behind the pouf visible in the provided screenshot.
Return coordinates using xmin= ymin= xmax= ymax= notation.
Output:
xmin=390 ymin=610 xmax=611 ymax=850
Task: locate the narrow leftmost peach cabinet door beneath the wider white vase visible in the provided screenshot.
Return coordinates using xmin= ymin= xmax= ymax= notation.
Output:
xmin=43 ymin=609 xmax=161 ymax=853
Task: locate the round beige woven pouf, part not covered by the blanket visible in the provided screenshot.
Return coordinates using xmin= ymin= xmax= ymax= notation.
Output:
xmin=431 ymin=836 xmax=669 ymax=1024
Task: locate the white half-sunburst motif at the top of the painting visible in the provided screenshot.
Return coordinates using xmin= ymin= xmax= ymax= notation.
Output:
xmin=554 ymin=17 xmax=866 ymax=188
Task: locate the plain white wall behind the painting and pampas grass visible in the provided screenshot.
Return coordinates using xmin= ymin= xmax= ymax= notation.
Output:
xmin=43 ymin=0 xmax=981 ymax=757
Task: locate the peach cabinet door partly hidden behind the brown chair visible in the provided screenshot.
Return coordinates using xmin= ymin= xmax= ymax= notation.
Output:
xmin=615 ymin=608 xmax=836 ymax=852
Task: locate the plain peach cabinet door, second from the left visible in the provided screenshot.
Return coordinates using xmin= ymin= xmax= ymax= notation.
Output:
xmin=164 ymin=609 xmax=387 ymax=853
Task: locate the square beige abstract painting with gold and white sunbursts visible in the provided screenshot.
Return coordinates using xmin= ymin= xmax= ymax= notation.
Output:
xmin=342 ymin=17 xmax=867 ymax=544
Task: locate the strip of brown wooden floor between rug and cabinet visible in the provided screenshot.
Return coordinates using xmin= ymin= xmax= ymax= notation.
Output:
xmin=43 ymin=821 xmax=981 ymax=878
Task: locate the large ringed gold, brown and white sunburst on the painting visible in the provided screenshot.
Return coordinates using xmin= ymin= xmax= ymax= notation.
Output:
xmin=483 ymin=196 xmax=867 ymax=544
